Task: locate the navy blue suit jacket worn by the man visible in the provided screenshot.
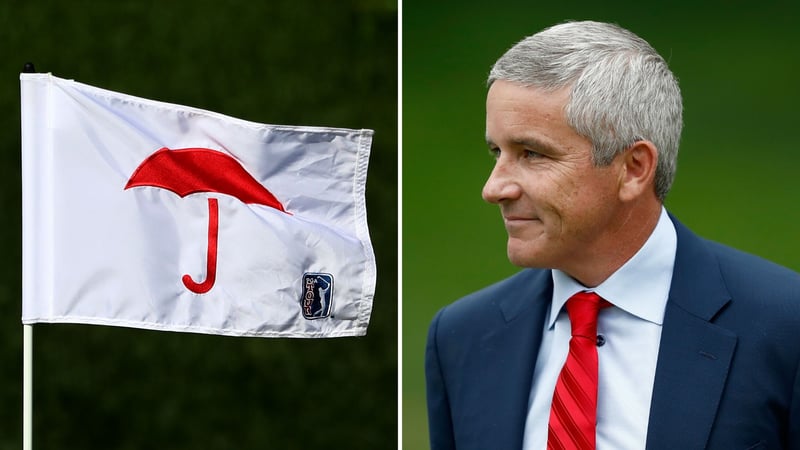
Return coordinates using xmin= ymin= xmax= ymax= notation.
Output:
xmin=425 ymin=219 xmax=800 ymax=450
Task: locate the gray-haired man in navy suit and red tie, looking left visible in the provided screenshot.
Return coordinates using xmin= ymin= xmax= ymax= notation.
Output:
xmin=426 ymin=22 xmax=800 ymax=450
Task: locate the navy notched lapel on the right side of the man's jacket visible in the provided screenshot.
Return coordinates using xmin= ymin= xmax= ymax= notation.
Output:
xmin=647 ymin=218 xmax=737 ymax=450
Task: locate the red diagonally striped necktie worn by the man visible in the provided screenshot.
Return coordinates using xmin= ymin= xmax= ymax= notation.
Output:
xmin=547 ymin=292 xmax=611 ymax=450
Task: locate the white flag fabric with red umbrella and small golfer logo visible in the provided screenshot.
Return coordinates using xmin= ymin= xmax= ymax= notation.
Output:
xmin=20 ymin=74 xmax=376 ymax=337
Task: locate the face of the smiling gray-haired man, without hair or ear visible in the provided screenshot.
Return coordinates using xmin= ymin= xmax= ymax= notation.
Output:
xmin=483 ymin=80 xmax=624 ymax=274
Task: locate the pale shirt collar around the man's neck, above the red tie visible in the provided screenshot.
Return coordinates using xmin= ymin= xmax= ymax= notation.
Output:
xmin=548 ymin=206 xmax=678 ymax=328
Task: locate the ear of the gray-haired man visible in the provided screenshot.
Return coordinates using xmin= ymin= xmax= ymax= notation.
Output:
xmin=619 ymin=140 xmax=658 ymax=202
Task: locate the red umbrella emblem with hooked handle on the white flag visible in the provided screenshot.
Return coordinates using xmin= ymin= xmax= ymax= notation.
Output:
xmin=125 ymin=147 xmax=289 ymax=294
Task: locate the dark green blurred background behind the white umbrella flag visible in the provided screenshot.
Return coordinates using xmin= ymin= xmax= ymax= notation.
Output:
xmin=0 ymin=0 xmax=398 ymax=450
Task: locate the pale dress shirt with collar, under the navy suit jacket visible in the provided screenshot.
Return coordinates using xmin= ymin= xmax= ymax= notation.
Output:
xmin=522 ymin=208 xmax=678 ymax=450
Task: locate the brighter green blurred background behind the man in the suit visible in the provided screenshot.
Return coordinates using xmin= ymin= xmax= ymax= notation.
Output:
xmin=402 ymin=0 xmax=800 ymax=449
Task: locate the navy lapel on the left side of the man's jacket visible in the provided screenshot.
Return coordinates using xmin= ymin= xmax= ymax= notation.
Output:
xmin=465 ymin=271 xmax=552 ymax=449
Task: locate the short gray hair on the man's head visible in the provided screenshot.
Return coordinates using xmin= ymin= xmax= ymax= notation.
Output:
xmin=488 ymin=21 xmax=683 ymax=200
